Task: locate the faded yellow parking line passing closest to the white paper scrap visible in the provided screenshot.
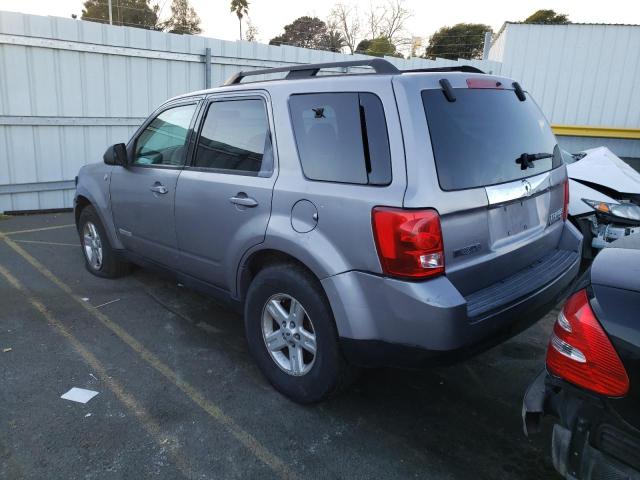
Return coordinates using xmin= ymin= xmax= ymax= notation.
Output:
xmin=0 ymin=265 xmax=199 ymax=479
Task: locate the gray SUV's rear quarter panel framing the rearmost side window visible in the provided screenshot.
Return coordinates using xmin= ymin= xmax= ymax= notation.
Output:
xmin=252 ymin=75 xmax=406 ymax=279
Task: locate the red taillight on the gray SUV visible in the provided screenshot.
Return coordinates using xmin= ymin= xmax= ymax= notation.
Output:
xmin=371 ymin=207 xmax=444 ymax=278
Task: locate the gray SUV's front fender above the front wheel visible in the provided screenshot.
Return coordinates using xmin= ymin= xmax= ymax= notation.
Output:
xmin=73 ymin=163 xmax=124 ymax=250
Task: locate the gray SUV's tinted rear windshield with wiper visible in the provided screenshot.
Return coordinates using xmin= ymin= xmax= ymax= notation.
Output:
xmin=422 ymin=88 xmax=562 ymax=190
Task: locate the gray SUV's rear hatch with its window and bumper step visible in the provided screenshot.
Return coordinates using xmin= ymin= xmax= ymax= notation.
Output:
xmin=398 ymin=74 xmax=577 ymax=317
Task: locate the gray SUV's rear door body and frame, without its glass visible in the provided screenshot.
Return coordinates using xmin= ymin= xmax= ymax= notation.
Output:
xmin=175 ymin=90 xmax=278 ymax=290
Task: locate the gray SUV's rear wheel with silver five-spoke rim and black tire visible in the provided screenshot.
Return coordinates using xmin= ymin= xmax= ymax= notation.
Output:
xmin=244 ymin=264 xmax=356 ymax=404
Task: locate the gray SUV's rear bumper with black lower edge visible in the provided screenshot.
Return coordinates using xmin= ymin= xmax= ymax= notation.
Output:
xmin=322 ymin=224 xmax=581 ymax=367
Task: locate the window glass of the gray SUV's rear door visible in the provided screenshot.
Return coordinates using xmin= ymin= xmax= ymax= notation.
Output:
xmin=193 ymin=98 xmax=273 ymax=176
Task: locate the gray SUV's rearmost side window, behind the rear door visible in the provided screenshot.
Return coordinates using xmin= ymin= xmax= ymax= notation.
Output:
xmin=289 ymin=93 xmax=391 ymax=185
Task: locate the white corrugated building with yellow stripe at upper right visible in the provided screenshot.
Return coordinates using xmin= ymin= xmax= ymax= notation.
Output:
xmin=489 ymin=23 xmax=640 ymax=157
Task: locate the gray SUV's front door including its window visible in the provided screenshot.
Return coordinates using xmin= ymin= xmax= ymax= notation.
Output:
xmin=110 ymin=103 xmax=197 ymax=266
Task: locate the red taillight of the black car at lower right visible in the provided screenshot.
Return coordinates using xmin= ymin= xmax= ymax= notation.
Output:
xmin=547 ymin=290 xmax=629 ymax=397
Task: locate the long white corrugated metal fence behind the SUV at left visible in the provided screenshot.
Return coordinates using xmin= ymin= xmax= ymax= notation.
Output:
xmin=0 ymin=12 xmax=500 ymax=212
